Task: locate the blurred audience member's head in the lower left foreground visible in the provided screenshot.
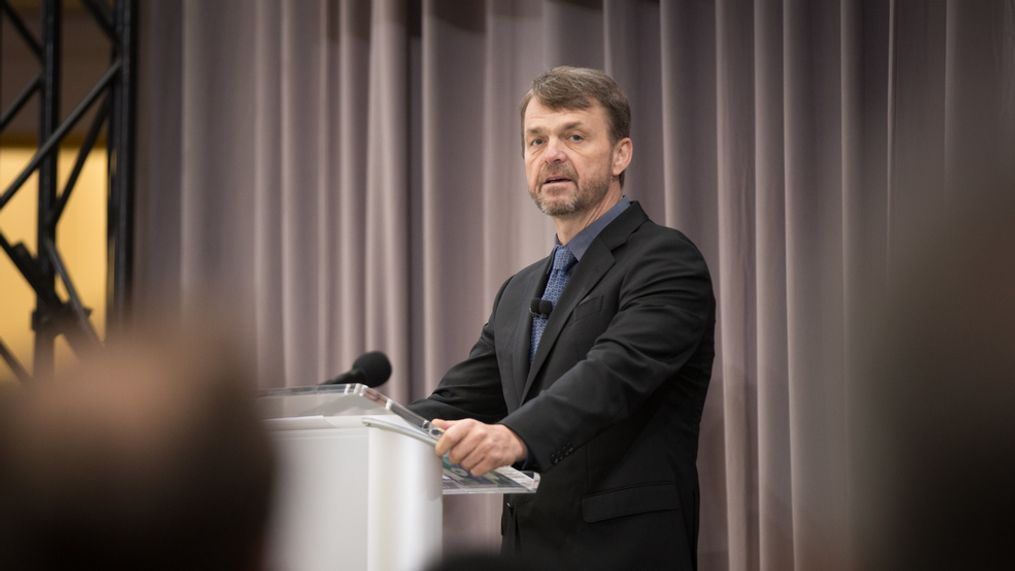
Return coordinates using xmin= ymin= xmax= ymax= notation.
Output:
xmin=0 ymin=332 xmax=274 ymax=570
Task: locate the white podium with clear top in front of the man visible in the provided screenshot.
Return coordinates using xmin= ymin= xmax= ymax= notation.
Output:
xmin=259 ymin=384 xmax=442 ymax=571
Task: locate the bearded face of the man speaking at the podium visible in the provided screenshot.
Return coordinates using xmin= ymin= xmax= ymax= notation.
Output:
xmin=522 ymin=97 xmax=629 ymax=217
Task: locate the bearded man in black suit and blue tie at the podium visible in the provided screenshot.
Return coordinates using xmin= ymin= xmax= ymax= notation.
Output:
xmin=412 ymin=67 xmax=715 ymax=569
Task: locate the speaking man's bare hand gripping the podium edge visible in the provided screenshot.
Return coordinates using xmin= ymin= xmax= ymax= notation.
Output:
xmin=433 ymin=419 xmax=526 ymax=476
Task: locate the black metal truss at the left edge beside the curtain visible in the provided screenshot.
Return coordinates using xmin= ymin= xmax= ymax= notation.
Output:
xmin=0 ymin=0 xmax=137 ymax=381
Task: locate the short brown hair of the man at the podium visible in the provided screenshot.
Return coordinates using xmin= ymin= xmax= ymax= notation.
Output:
xmin=521 ymin=66 xmax=631 ymax=185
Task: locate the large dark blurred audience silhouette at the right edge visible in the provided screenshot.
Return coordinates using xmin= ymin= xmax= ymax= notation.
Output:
xmin=851 ymin=186 xmax=1015 ymax=569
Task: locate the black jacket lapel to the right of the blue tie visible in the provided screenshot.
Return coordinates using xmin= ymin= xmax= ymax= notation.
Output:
xmin=515 ymin=202 xmax=649 ymax=404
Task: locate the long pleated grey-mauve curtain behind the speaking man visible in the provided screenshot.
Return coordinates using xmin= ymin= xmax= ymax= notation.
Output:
xmin=136 ymin=0 xmax=1015 ymax=570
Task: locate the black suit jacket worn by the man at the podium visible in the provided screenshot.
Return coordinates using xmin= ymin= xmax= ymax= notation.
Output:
xmin=412 ymin=203 xmax=716 ymax=569
